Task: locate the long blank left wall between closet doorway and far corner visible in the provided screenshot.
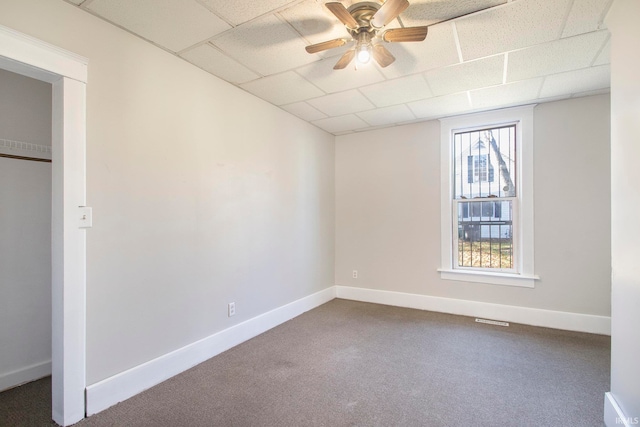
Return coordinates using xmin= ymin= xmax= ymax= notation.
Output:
xmin=0 ymin=0 xmax=334 ymax=385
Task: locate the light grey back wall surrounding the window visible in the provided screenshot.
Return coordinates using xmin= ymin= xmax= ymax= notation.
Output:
xmin=335 ymin=95 xmax=611 ymax=316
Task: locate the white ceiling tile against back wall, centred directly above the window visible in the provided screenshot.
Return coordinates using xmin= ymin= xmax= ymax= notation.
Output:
xmin=470 ymin=78 xmax=542 ymax=109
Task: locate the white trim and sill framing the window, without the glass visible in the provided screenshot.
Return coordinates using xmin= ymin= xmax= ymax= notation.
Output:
xmin=438 ymin=105 xmax=539 ymax=288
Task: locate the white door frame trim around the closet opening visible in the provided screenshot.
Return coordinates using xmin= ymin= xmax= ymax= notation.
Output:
xmin=0 ymin=26 xmax=88 ymax=426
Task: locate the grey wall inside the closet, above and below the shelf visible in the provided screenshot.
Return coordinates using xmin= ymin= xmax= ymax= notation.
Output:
xmin=0 ymin=70 xmax=51 ymax=390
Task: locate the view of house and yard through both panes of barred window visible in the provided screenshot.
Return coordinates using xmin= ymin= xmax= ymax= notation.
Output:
xmin=453 ymin=124 xmax=518 ymax=271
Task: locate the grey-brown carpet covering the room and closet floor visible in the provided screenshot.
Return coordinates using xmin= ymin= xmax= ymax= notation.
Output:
xmin=0 ymin=299 xmax=610 ymax=427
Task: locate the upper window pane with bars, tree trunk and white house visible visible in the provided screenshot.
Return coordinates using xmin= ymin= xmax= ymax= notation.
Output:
xmin=453 ymin=125 xmax=516 ymax=199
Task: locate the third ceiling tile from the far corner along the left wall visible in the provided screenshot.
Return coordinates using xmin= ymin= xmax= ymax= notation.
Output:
xmin=240 ymin=71 xmax=324 ymax=105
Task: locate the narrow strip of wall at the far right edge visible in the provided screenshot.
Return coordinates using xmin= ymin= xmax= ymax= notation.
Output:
xmin=607 ymin=0 xmax=640 ymax=426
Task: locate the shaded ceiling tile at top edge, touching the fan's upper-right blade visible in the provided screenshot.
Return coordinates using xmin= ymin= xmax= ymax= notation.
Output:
xmin=400 ymin=0 xmax=507 ymax=27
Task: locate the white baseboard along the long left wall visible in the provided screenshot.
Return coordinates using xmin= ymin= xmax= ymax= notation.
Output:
xmin=86 ymin=286 xmax=336 ymax=415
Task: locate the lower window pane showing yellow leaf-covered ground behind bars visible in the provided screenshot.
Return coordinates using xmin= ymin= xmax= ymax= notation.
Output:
xmin=457 ymin=200 xmax=514 ymax=269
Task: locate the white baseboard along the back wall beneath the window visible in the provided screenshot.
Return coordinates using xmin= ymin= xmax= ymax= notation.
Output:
xmin=336 ymin=285 xmax=611 ymax=335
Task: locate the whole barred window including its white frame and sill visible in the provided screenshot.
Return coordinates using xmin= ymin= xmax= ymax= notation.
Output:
xmin=440 ymin=107 xmax=537 ymax=287
